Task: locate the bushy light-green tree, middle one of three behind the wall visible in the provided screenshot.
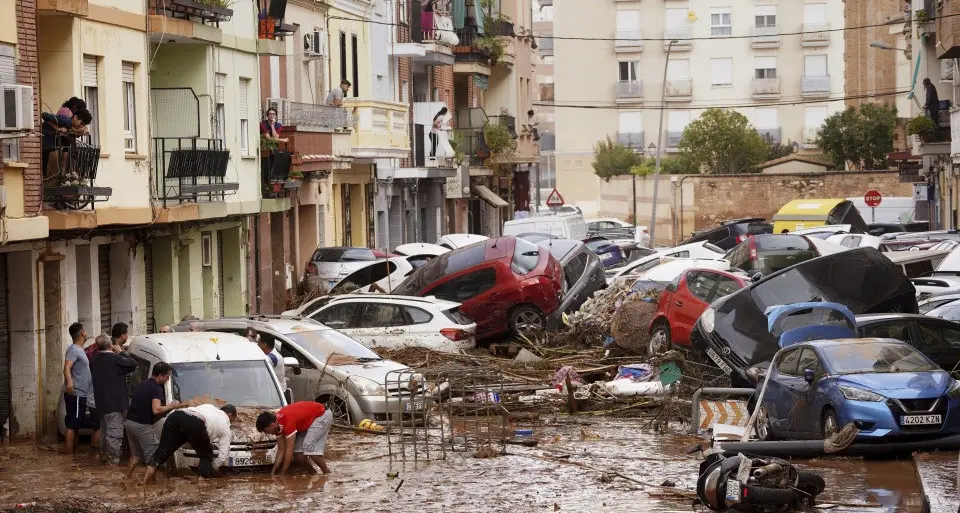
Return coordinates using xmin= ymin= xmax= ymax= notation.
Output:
xmin=679 ymin=108 xmax=769 ymax=174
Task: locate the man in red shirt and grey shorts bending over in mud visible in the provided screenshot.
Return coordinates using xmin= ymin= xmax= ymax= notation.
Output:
xmin=257 ymin=401 xmax=333 ymax=475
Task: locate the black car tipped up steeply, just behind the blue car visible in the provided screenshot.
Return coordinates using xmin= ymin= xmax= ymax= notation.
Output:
xmin=690 ymin=248 xmax=917 ymax=387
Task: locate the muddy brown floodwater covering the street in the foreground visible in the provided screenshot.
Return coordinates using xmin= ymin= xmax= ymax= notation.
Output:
xmin=0 ymin=418 xmax=920 ymax=513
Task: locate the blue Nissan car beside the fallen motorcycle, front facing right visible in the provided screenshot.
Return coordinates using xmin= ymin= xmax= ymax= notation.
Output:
xmin=757 ymin=338 xmax=960 ymax=441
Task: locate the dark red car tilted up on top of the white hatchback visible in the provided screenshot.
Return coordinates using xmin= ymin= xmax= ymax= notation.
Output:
xmin=393 ymin=237 xmax=563 ymax=339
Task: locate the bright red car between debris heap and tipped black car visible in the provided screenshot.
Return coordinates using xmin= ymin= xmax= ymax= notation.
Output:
xmin=650 ymin=269 xmax=748 ymax=353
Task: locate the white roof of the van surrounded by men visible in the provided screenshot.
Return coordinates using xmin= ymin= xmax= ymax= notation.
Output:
xmin=128 ymin=331 xmax=263 ymax=363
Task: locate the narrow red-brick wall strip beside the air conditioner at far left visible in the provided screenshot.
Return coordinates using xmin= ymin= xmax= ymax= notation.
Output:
xmin=16 ymin=0 xmax=43 ymax=216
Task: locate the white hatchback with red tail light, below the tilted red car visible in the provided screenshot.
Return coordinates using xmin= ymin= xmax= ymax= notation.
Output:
xmin=284 ymin=294 xmax=477 ymax=353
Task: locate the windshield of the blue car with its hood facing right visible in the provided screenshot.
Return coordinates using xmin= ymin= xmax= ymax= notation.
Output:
xmin=823 ymin=342 xmax=939 ymax=374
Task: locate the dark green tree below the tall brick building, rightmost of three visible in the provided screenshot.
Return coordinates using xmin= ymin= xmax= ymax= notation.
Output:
xmin=816 ymin=103 xmax=897 ymax=170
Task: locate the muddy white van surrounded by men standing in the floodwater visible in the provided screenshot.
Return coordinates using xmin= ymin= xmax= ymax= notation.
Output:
xmin=127 ymin=332 xmax=295 ymax=468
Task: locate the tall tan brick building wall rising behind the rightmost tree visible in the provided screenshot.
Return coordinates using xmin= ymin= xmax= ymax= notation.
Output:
xmin=843 ymin=0 xmax=904 ymax=106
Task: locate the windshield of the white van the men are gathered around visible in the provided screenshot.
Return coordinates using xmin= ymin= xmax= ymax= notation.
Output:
xmin=171 ymin=360 xmax=283 ymax=408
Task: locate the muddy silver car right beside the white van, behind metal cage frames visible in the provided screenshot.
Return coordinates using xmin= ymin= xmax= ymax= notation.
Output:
xmin=184 ymin=316 xmax=429 ymax=425
